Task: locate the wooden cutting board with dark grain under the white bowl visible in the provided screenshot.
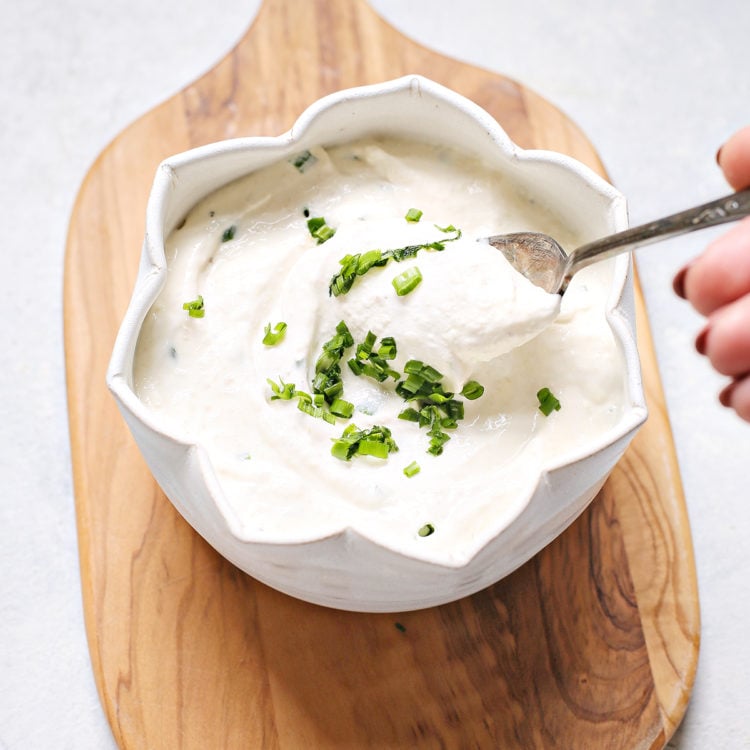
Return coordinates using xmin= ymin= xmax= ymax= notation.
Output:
xmin=64 ymin=0 xmax=699 ymax=750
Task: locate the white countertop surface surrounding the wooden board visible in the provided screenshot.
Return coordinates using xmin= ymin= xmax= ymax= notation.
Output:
xmin=0 ymin=0 xmax=750 ymax=750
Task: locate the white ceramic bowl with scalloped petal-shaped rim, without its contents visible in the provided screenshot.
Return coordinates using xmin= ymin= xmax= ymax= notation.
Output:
xmin=107 ymin=76 xmax=646 ymax=611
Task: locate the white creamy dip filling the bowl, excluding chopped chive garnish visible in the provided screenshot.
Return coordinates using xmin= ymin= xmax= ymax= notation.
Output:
xmin=134 ymin=139 xmax=625 ymax=564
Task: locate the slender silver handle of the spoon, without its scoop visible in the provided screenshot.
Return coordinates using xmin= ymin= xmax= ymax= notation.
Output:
xmin=566 ymin=188 xmax=750 ymax=279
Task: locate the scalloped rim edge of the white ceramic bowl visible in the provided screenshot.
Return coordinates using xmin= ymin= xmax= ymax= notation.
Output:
xmin=106 ymin=75 xmax=647 ymax=600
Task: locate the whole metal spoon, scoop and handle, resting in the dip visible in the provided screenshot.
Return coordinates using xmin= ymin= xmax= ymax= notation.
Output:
xmin=487 ymin=188 xmax=750 ymax=294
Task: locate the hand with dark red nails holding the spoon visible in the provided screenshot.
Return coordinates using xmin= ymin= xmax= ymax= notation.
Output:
xmin=674 ymin=126 xmax=750 ymax=422
